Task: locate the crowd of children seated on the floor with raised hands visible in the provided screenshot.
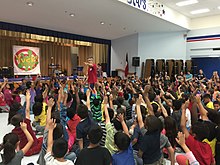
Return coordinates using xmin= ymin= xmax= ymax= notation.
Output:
xmin=0 ymin=70 xmax=220 ymax=165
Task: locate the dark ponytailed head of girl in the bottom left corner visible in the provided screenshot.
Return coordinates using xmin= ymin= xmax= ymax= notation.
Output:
xmin=3 ymin=133 xmax=19 ymax=164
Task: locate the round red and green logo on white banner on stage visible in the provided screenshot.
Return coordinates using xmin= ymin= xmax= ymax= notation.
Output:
xmin=14 ymin=49 xmax=39 ymax=71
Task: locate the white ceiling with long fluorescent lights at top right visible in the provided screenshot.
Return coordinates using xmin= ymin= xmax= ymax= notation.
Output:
xmin=158 ymin=0 xmax=220 ymax=18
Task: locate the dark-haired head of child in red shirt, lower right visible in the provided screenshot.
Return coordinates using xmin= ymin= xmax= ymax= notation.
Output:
xmin=192 ymin=121 xmax=210 ymax=142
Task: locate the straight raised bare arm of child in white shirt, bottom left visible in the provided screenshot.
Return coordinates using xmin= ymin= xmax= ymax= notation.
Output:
xmin=47 ymin=119 xmax=56 ymax=153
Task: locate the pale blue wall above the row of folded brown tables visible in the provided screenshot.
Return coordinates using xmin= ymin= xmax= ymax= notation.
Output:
xmin=138 ymin=32 xmax=186 ymax=73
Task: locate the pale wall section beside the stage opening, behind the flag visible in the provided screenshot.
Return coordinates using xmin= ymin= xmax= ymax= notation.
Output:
xmin=111 ymin=34 xmax=138 ymax=75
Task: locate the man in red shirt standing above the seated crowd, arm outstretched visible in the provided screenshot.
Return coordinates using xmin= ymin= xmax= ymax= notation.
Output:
xmin=85 ymin=57 xmax=97 ymax=89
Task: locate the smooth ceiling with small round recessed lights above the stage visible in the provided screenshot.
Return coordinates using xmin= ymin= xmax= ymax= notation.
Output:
xmin=0 ymin=0 xmax=187 ymax=40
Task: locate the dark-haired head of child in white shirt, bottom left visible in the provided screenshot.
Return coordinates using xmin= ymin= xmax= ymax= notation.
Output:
xmin=52 ymin=138 xmax=68 ymax=158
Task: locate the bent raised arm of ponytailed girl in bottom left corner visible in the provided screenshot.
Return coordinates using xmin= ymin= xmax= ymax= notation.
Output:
xmin=20 ymin=122 xmax=34 ymax=155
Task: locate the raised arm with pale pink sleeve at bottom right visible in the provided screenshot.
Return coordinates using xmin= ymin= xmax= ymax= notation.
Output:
xmin=176 ymin=132 xmax=199 ymax=165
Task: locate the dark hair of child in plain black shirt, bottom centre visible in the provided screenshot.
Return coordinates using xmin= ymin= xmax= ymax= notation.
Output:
xmin=88 ymin=125 xmax=103 ymax=144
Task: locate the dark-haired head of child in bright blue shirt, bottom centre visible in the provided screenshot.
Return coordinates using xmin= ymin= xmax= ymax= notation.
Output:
xmin=114 ymin=132 xmax=131 ymax=151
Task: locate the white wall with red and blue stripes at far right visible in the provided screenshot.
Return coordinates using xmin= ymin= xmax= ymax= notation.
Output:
xmin=186 ymin=26 xmax=220 ymax=59
